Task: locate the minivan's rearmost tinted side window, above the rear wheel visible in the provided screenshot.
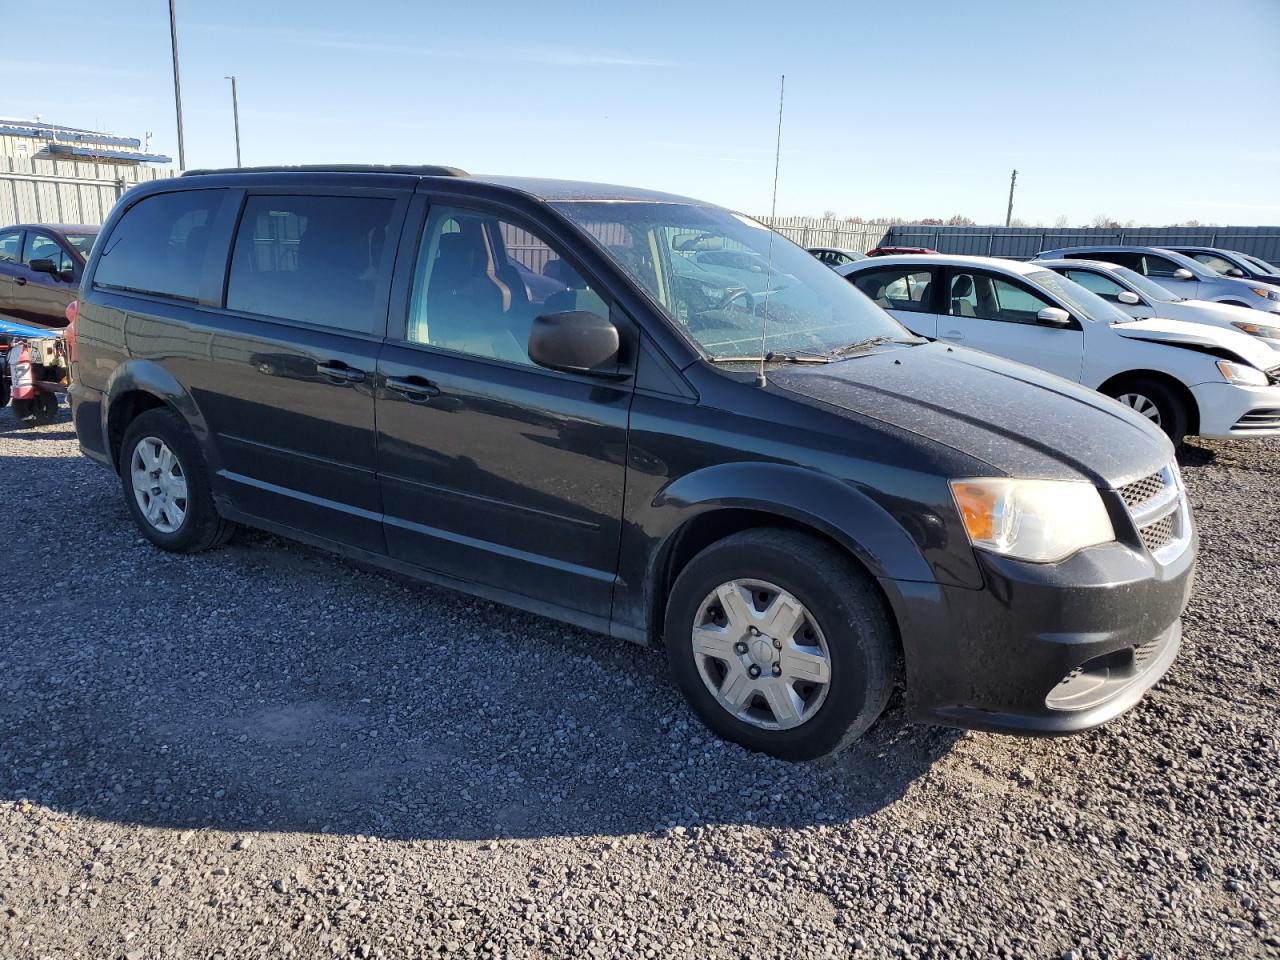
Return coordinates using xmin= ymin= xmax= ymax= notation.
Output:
xmin=93 ymin=189 xmax=227 ymax=301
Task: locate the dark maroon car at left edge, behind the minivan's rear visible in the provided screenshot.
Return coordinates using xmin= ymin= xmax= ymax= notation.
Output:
xmin=0 ymin=224 xmax=99 ymax=328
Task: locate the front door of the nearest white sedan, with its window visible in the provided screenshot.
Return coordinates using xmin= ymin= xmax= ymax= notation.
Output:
xmin=938 ymin=268 xmax=1084 ymax=381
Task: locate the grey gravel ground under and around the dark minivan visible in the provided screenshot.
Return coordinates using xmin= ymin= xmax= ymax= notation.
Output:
xmin=0 ymin=401 xmax=1280 ymax=960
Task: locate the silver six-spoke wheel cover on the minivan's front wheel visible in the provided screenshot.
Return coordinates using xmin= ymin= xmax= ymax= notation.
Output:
xmin=692 ymin=580 xmax=831 ymax=730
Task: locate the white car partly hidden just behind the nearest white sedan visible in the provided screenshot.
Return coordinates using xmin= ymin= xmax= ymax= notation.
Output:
xmin=1030 ymin=260 xmax=1280 ymax=351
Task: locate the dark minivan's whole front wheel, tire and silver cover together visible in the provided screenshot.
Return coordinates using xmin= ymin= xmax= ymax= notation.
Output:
xmin=664 ymin=529 xmax=893 ymax=760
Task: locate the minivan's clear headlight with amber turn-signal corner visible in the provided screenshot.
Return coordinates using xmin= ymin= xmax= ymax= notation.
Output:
xmin=951 ymin=477 xmax=1116 ymax=563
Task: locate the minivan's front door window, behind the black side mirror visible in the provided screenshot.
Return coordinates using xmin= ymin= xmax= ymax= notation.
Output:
xmin=406 ymin=207 xmax=609 ymax=365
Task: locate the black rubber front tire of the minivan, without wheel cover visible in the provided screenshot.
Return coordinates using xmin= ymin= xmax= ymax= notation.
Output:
xmin=664 ymin=529 xmax=895 ymax=760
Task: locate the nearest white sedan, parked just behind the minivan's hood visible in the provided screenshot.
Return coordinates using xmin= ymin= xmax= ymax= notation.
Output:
xmin=838 ymin=256 xmax=1280 ymax=443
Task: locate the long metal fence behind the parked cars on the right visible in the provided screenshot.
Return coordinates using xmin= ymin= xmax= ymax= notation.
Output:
xmin=756 ymin=216 xmax=1280 ymax=264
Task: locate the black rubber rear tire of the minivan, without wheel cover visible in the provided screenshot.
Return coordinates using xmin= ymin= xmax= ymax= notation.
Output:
xmin=119 ymin=407 xmax=236 ymax=553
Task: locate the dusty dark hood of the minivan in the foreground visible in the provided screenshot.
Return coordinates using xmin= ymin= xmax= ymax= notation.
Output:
xmin=769 ymin=343 xmax=1172 ymax=486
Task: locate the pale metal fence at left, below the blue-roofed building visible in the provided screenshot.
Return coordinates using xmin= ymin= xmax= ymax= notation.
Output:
xmin=0 ymin=157 xmax=173 ymax=227
